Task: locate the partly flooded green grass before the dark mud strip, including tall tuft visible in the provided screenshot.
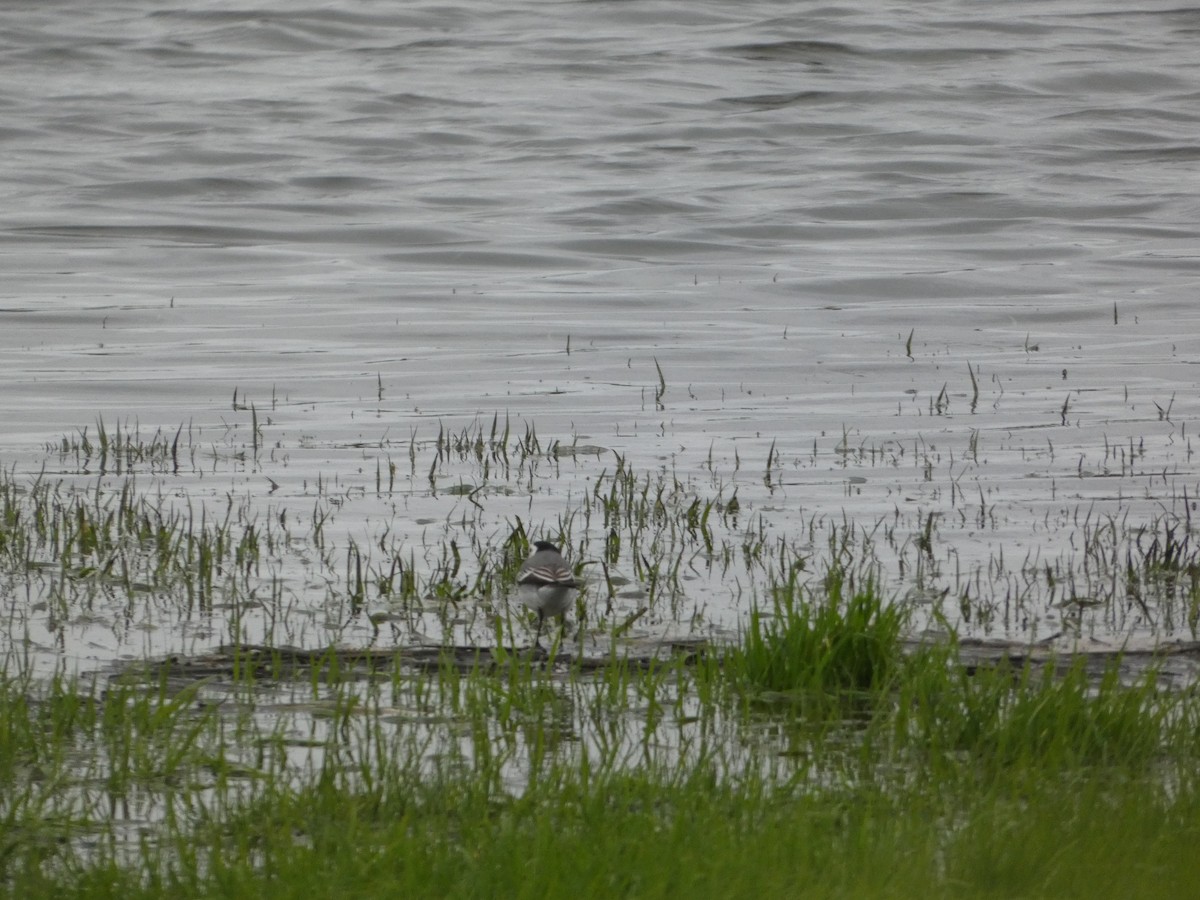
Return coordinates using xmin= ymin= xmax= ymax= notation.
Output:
xmin=7 ymin=581 xmax=1200 ymax=898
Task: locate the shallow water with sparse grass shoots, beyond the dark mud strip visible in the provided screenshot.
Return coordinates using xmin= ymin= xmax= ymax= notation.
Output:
xmin=4 ymin=322 xmax=1200 ymax=671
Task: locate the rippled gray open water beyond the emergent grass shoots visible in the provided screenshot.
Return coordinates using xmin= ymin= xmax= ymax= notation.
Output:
xmin=0 ymin=0 xmax=1200 ymax=676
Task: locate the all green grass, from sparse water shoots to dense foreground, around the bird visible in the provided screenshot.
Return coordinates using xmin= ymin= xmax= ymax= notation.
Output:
xmin=0 ymin=420 xmax=1200 ymax=900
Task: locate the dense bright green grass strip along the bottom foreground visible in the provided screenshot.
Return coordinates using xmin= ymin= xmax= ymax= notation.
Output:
xmin=10 ymin=734 xmax=1200 ymax=898
